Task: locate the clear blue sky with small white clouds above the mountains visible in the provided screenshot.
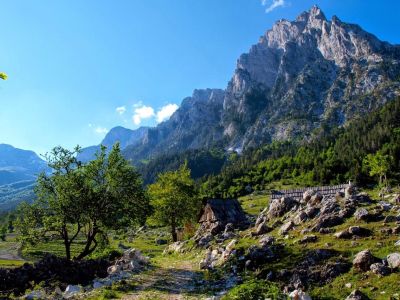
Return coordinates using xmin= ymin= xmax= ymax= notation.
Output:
xmin=0 ymin=0 xmax=400 ymax=153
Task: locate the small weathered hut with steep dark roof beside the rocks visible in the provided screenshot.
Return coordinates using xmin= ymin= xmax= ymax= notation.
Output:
xmin=198 ymin=199 xmax=249 ymax=235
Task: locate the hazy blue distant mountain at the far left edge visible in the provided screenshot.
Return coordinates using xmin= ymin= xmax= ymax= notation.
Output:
xmin=0 ymin=144 xmax=47 ymax=211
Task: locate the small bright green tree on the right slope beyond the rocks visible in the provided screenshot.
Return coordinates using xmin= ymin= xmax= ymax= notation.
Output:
xmin=363 ymin=151 xmax=392 ymax=185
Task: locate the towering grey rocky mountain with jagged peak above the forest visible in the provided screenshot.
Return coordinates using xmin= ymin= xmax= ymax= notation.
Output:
xmin=86 ymin=6 xmax=400 ymax=163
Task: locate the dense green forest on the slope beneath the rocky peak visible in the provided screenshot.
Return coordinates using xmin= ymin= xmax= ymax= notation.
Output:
xmin=200 ymin=98 xmax=400 ymax=198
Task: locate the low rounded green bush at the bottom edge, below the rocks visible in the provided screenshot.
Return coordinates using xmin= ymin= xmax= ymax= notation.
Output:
xmin=222 ymin=280 xmax=287 ymax=300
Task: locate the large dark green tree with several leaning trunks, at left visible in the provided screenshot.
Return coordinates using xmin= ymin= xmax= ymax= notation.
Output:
xmin=18 ymin=144 xmax=149 ymax=260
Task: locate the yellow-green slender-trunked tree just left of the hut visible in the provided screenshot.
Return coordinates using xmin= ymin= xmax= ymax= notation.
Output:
xmin=148 ymin=163 xmax=200 ymax=242
